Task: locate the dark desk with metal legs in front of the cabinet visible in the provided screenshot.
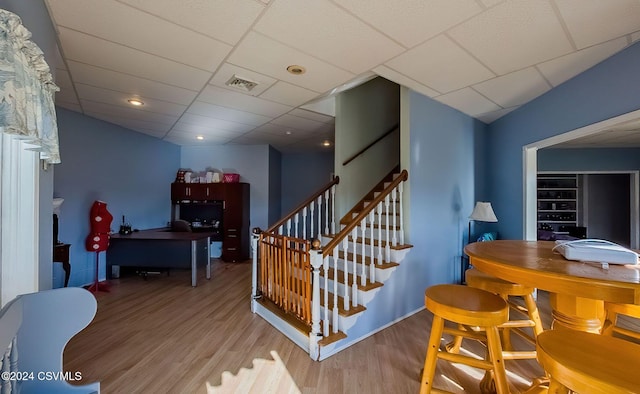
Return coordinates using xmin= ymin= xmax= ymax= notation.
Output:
xmin=107 ymin=228 xmax=211 ymax=287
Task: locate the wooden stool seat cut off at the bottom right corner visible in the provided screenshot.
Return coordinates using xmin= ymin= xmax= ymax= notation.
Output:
xmin=536 ymin=329 xmax=640 ymax=394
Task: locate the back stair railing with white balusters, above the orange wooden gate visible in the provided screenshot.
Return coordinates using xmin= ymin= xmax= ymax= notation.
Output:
xmin=266 ymin=177 xmax=340 ymax=239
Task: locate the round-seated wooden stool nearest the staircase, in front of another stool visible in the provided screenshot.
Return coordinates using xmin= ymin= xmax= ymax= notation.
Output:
xmin=420 ymin=284 xmax=509 ymax=394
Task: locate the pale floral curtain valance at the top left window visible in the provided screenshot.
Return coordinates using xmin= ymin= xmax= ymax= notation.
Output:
xmin=0 ymin=9 xmax=60 ymax=164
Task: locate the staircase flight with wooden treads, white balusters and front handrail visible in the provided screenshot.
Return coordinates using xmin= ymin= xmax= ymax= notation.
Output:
xmin=256 ymin=171 xmax=412 ymax=360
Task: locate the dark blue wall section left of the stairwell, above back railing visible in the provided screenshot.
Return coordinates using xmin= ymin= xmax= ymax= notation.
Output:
xmin=278 ymin=152 xmax=333 ymax=215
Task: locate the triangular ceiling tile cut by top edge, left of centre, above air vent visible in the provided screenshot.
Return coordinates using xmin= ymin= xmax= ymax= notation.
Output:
xmin=120 ymin=0 xmax=265 ymax=45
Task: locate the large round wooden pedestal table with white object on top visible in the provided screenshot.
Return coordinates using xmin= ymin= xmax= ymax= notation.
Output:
xmin=464 ymin=240 xmax=640 ymax=333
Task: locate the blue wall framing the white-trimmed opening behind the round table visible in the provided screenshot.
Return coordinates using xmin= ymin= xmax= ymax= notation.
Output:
xmin=487 ymin=43 xmax=640 ymax=239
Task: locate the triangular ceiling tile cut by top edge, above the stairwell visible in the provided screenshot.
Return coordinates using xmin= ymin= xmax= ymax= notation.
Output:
xmin=334 ymin=0 xmax=482 ymax=48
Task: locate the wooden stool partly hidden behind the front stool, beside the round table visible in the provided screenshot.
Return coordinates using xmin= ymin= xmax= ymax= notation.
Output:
xmin=447 ymin=268 xmax=543 ymax=360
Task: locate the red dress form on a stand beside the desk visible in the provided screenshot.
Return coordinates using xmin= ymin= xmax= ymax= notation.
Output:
xmin=85 ymin=200 xmax=113 ymax=292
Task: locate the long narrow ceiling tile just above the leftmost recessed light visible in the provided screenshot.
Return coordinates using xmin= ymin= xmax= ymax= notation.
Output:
xmin=69 ymin=61 xmax=198 ymax=105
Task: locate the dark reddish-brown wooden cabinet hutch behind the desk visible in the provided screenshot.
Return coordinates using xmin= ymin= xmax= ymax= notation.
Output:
xmin=171 ymin=183 xmax=250 ymax=261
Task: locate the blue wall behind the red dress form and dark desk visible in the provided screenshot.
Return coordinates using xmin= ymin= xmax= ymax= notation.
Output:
xmin=54 ymin=108 xmax=180 ymax=286
